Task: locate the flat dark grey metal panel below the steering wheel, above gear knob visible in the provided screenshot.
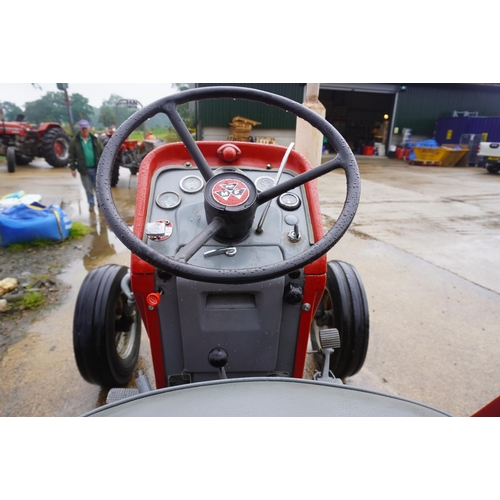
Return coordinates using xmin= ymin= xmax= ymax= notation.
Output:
xmin=177 ymin=272 xmax=285 ymax=374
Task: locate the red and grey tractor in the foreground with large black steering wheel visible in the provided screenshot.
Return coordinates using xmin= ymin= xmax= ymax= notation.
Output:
xmin=73 ymin=87 xmax=458 ymax=416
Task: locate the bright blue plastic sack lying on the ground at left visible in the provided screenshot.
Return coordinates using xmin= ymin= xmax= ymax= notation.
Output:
xmin=0 ymin=203 xmax=72 ymax=247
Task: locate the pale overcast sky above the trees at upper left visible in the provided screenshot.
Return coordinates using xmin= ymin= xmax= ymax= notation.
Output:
xmin=0 ymin=83 xmax=180 ymax=108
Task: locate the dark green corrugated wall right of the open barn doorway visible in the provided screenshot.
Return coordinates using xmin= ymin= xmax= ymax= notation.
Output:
xmin=394 ymin=84 xmax=500 ymax=136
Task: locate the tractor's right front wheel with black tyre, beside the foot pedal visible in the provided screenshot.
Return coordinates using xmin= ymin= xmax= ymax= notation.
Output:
xmin=311 ymin=260 xmax=370 ymax=379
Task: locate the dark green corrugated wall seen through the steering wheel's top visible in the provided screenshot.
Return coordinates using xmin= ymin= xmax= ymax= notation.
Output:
xmin=197 ymin=83 xmax=305 ymax=129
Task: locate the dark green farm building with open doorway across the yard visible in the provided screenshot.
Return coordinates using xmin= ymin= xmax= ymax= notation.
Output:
xmin=193 ymin=83 xmax=500 ymax=153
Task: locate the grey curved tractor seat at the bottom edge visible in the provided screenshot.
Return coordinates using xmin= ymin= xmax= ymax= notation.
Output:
xmin=83 ymin=378 xmax=451 ymax=417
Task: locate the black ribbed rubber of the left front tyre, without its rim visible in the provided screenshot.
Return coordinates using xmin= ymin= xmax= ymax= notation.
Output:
xmin=73 ymin=264 xmax=141 ymax=387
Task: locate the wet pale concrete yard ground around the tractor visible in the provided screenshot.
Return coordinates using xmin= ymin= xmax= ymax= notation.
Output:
xmin=0 ymin=157 xmax=500 ymax=416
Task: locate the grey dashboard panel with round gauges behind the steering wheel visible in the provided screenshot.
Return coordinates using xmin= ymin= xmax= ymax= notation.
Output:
xmin=144 ymin=166 xmax=313 ymax=269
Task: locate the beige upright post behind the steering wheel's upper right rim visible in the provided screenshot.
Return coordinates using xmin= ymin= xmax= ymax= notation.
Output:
xmin=295 ymin=83 xmax=326 ymax=167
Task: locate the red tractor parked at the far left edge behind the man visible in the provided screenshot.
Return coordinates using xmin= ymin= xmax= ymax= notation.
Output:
xmin=0 ymin=115 xmax=69 ymax=173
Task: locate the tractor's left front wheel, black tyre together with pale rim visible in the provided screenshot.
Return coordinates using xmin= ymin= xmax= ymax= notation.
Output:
xmin=73 ymin=264 xmax=141 ymax=387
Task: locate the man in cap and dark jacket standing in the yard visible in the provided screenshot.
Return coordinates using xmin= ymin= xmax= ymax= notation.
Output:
xmin=68 ymin=120 xmax=103 ymax=212
